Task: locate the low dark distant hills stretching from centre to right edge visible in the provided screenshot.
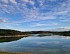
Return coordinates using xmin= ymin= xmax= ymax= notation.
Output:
xmin=30 ymin=31 xmax=70 ymax=36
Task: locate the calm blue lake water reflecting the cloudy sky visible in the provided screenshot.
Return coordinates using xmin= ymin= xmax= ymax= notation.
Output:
xmin=0 ymin=35 xmax=70 ymax=54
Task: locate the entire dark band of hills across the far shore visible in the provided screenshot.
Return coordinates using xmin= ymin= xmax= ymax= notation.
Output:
xmin=0 ymin=29 xmax=70 ymax=37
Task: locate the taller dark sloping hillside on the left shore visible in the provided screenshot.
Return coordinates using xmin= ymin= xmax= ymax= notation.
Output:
xmin=0 ymin=29 xmax=28 ymax=36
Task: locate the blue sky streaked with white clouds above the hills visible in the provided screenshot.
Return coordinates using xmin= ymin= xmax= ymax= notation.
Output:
xmin=0 ymin=0 xmax=70 ymax=31
